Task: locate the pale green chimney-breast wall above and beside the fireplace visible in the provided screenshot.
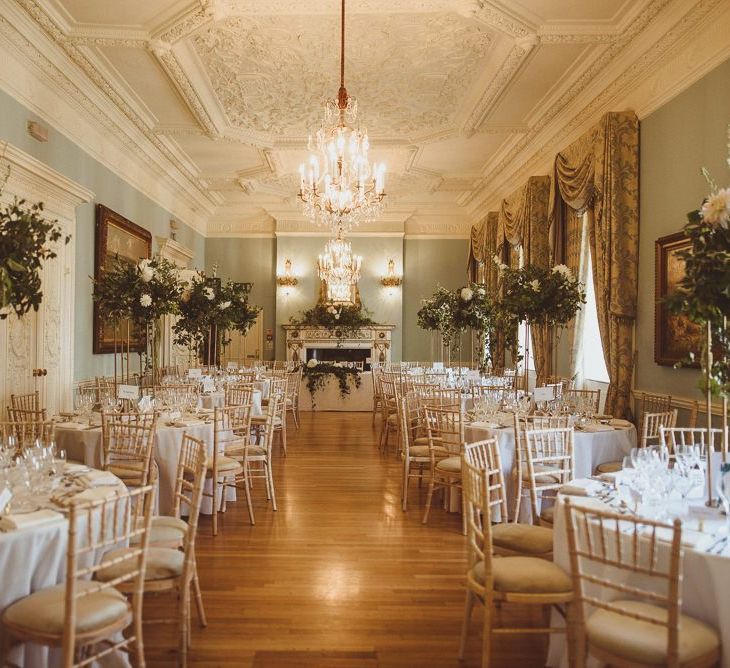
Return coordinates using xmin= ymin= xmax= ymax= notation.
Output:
xmin=275 ymin=236 xmax=403 ymax=360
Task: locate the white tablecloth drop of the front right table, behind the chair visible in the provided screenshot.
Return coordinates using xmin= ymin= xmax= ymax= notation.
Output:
xmin=547 ymin=497 xmax=730 ymax=668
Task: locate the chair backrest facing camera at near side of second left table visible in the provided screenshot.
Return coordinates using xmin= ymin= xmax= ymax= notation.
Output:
xmin=101 ymin=413 xmax=157 ymax=487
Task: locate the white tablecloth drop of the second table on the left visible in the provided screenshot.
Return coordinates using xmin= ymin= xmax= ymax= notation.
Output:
xmin=54 ymin=418 xmax=236 ymax=515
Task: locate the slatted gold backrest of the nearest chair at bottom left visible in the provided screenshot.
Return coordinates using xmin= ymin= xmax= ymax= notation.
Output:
xmin=62 ymin=485 xmax=152 ymax=666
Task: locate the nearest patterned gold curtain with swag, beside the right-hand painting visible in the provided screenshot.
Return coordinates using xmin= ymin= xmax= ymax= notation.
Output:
xmin=550 ymin=112 xmax=639 ymax=417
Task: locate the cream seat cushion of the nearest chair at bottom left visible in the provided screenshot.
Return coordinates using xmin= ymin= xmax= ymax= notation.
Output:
xmin=2 ymin=581 xmax=131 ymax=635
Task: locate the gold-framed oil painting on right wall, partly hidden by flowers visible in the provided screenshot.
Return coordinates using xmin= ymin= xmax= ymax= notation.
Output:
xmin=654 ymin=232 xmax=703 ymax=367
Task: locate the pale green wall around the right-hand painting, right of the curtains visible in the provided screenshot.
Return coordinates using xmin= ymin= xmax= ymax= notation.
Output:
xmin=636 ymin=61 xmax=730 ymax=398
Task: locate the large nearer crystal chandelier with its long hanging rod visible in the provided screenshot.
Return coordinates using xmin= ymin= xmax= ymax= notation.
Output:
xmin=298 ymin=0 xmax=385 ymax=229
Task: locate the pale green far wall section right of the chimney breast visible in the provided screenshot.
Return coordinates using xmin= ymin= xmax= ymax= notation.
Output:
xmin=403 ymin=239 xmax=469 ymax=362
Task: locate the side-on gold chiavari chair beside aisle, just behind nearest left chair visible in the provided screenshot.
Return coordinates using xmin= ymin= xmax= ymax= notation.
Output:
xmin=96 ymin=434 xmax=207 ymax=666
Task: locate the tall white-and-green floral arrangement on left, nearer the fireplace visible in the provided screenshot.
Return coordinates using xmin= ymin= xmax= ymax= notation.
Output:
xmin=173 ymin=272 xmax=261 ymax=353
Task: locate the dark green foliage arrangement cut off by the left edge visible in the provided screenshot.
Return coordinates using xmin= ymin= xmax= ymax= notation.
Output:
xmin=0 ymin=198 xmax=71 ymax=320
